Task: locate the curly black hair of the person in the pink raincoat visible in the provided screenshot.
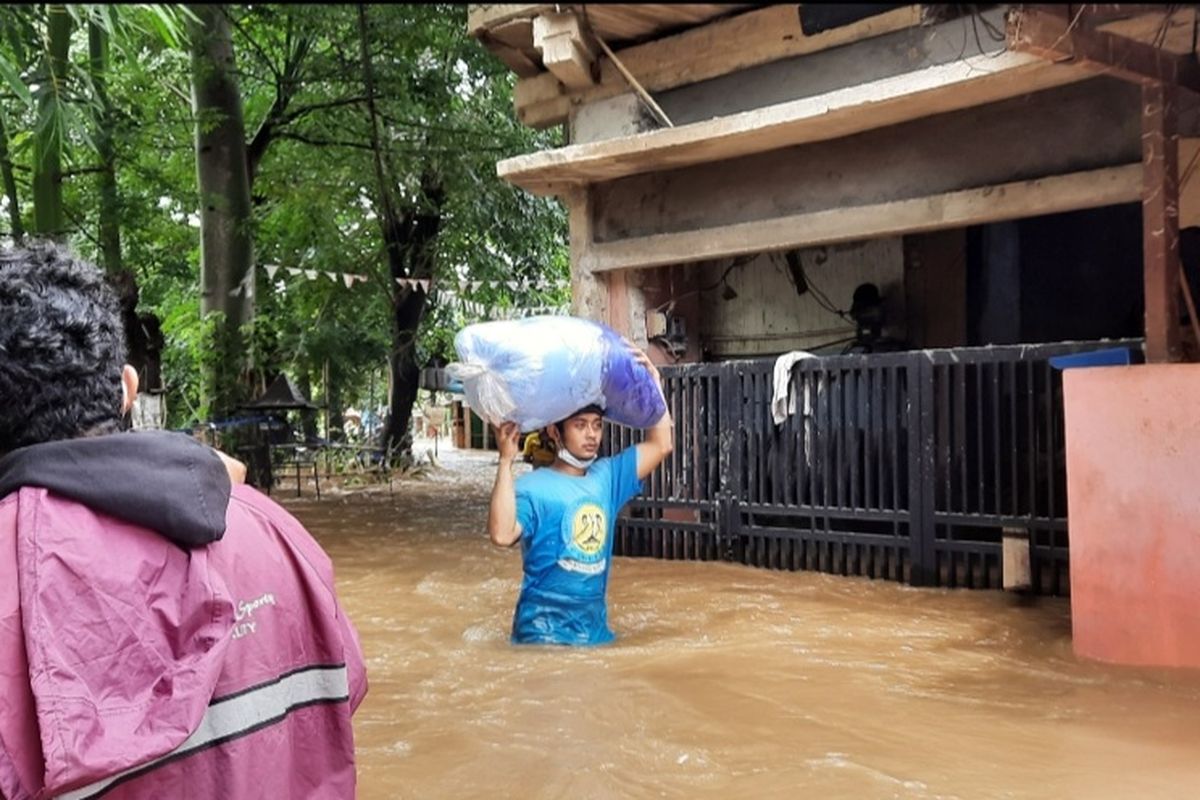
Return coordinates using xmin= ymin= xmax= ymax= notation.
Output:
xmin=0 ymin=241 xmax=125 ymax=453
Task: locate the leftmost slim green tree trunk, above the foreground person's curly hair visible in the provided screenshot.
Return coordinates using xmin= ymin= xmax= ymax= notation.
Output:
xmin=34 ymin=5 xmax=71 ymax=239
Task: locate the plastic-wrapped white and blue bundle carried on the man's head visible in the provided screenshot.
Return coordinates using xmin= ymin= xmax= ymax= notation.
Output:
xmin=448 ymin=317 xmax=666 ymax=431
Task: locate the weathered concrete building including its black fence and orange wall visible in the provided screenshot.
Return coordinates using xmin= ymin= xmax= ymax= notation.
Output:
xmin=469 ymin=4 xmax=1200 ymax=664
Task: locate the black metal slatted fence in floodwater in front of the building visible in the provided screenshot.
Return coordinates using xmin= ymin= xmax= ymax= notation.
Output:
xmin=610 ymin=342 xmax=1141 ymax=594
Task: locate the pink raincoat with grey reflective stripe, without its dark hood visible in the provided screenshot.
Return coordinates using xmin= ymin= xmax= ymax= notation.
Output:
xmin=0 ymin=486 xmax=366 ymax=800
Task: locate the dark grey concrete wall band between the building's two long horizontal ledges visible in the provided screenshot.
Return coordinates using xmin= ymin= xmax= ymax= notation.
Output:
xmin=593 ymin=78 xmax=1141 ymax=242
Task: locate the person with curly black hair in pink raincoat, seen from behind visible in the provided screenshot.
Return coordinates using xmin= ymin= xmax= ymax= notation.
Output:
xmin=0 ymin=243 xmax=366 ymax=800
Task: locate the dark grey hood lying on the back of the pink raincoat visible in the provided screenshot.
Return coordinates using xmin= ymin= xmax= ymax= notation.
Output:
xmin=0 ymin=431 xmax=230 ymax=548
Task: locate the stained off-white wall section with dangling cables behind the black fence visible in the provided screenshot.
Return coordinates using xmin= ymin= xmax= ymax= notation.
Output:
xmin=692 ymin=239 xmax=906 ymax=357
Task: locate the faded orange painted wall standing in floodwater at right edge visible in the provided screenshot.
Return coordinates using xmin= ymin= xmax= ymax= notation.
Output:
xmin=1063 ymin=365 xmax=1200 ymax=667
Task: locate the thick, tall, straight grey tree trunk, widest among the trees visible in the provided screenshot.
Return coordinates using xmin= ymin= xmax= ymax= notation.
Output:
xmin=188 ymin=5 xmax=254 ymax=416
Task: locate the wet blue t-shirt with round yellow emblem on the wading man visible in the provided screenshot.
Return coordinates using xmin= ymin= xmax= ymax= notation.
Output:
xmin=512 ymin=447 xmax=642 ymax=644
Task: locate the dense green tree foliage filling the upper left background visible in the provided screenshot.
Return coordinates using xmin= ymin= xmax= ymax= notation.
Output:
xmin=0 ymin=4 xmax=568 ymax=434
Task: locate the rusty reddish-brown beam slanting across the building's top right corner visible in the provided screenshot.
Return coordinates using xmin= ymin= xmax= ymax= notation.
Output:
xmin=1008 ymin=6 xmax=1200 ymax=92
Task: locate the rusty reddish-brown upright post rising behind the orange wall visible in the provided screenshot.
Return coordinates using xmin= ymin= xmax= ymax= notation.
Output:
xmin=1141 ymin=83 xmax=1182 ymax=363
